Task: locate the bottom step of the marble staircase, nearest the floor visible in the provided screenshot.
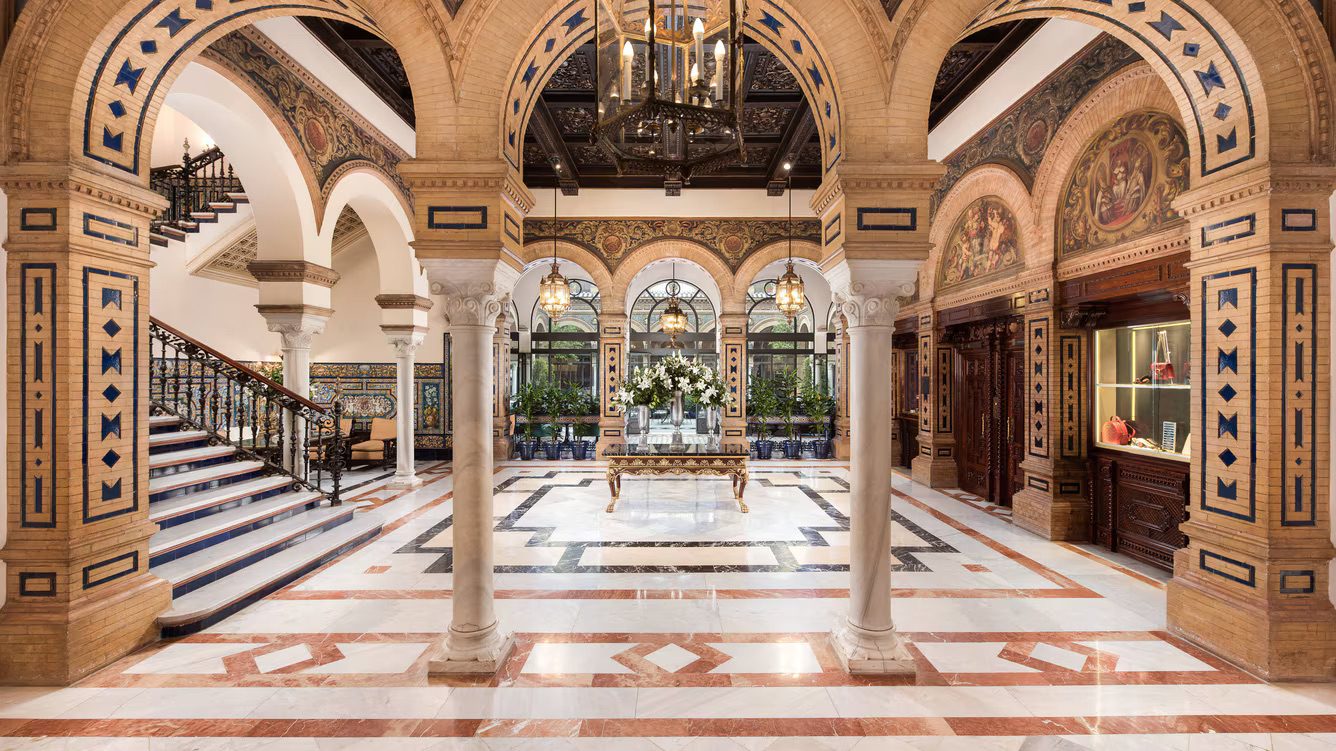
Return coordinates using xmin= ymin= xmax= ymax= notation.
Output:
xmin=155 ymin=506 xmax=381 ymax=637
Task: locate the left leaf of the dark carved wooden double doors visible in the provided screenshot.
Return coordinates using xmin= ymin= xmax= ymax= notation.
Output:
xmin=955 ymin=347 xmax=994 ymax=498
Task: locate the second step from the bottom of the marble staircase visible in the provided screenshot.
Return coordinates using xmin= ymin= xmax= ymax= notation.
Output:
xmin=151 ymin=505 xmax=354 ymax=597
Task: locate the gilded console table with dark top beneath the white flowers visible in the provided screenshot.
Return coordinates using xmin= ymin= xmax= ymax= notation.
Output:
xmin=604 ymin=444 xmax=749 ymax=513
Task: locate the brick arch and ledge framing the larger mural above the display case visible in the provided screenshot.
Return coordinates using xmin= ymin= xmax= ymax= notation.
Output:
xmin=1033 ymin=64 xmax=1188 ymax=273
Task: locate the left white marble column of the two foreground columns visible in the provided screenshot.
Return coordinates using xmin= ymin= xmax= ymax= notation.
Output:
xmin=424 ymin=259 xmax=518 ymax=673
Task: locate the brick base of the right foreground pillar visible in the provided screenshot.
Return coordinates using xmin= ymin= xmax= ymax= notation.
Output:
xmin=1166 ymin=548 xmax=1336 ymax=682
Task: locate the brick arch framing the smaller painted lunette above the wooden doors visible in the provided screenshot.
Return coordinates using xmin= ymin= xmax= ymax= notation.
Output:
xmin=919 ymin=164 xmax=1053 ymax=301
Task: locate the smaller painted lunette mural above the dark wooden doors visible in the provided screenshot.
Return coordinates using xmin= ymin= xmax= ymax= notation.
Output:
xmin=938 ymin=196 xmax=1021 ymax=289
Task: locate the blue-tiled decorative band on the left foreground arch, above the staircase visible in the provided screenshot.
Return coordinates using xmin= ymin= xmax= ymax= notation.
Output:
xmin=83 ymin=0 xmax=375 ymax=175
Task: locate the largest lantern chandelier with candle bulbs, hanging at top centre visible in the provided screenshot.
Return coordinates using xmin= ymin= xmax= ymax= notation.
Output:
xmin=593 ymin=0 xmax=745 ymax=195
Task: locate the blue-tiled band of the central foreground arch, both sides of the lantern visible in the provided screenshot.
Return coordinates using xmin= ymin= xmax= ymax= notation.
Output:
xmin=501 ymin=0 xmax=843 ymax=174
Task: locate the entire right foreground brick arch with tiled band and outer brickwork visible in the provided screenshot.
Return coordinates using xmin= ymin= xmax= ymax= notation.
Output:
xmin=890 ymin=0 xmax=1336 ymax=176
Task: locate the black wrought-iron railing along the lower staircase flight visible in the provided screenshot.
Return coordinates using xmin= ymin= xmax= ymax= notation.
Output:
xmin=148 ymin=318 xmax=349 ymax=505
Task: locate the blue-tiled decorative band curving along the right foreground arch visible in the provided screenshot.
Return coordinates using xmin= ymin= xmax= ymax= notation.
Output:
xmin=967 ymin=0 xmax=1257 ymax=176
